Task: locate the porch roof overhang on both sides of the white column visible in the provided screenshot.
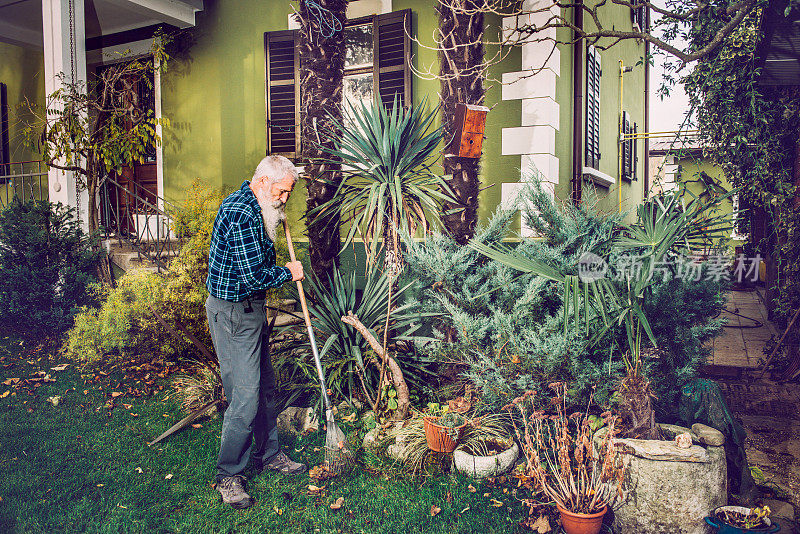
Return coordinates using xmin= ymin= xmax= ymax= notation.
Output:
xmin=0 ymin=0 xmax=203 ymax=48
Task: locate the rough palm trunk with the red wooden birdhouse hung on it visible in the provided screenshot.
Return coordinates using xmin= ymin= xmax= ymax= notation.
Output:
xmin=438 ymin=0 xmax=484 ymax=245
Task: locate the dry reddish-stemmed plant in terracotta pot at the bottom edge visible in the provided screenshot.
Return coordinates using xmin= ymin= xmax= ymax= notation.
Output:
xmin=505 ymin=383 xmax=625 ymax=534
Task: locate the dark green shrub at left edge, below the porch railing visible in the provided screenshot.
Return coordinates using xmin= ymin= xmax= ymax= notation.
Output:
xmin=0 ymin=198 xmax=103 ymax=333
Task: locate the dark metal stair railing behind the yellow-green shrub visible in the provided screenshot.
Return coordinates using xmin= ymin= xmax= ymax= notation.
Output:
xmin=99 ymin=177 xmax=182 ymax=271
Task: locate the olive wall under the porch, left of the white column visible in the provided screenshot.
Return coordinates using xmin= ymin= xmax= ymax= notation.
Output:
xmin=0 ymin=43 xmax=45 ymax=161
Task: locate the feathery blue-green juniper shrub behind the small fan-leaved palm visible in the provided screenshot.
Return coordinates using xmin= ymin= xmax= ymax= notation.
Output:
xmin=406 ymin=177 xmax=725 ymax=418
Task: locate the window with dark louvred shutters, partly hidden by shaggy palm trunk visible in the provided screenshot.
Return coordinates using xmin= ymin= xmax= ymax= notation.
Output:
xmin=264 ymin=10 xmax=411 ymax=158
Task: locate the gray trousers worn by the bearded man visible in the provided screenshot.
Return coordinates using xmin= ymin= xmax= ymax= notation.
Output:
xmin=206 ymin=295 xmax=279 ymax=481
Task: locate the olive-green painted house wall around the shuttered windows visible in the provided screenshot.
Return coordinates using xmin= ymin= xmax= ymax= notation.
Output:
xmin=0 ymin=0 xmax=646 ymax=237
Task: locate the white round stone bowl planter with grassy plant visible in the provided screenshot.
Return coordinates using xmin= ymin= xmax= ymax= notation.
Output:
xmin=453 ymin=414 xmax=519 ymax=478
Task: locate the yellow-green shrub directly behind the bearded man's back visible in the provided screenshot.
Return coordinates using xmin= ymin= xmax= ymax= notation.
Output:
xmin=65 ymin=181 xmax=304 ymax=368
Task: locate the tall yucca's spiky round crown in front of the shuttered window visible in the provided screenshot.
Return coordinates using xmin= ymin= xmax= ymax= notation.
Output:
xmin=311 ymin=99 xmax=451 ymax=265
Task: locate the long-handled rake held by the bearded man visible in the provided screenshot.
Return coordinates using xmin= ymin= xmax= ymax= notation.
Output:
xmin=283 ymin=220 xmax=353 ymax=475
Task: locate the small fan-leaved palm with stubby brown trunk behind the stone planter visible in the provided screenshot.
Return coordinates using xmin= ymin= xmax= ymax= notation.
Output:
xmin=469 ymin=184 xmax=736 ymax=438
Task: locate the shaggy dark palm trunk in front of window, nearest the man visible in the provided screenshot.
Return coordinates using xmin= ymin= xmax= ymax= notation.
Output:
xmin=299 ymin=0 xmax=347 ymax=283
